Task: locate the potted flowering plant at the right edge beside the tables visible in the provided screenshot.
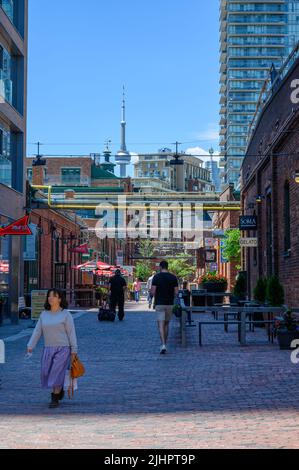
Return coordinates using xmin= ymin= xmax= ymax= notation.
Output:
xmin=273 ymin=310 xmax=299 ymax=349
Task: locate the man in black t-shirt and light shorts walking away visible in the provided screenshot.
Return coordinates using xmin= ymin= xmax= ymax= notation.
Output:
xmin=151 ymin=261 xmax=179 ymax=354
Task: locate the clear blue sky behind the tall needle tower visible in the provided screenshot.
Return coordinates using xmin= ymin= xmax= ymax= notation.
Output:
xmin=27 ymin=0 xmax=219 ymax=176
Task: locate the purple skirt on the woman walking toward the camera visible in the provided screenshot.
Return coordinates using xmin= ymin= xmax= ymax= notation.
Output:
xmin=41 ymin=346 xmax=71 ymax=388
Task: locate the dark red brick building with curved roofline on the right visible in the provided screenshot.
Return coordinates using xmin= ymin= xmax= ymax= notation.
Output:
xmin=241 ymin=47 xmax=299 ymax=306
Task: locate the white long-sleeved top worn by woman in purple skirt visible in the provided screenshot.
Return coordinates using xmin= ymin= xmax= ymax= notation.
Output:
xmin=27 ymin=310 xmax=78 ymax=353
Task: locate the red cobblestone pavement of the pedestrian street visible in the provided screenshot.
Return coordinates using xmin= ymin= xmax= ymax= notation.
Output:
xmin=0 ymin=304 xmax=299 ymax=449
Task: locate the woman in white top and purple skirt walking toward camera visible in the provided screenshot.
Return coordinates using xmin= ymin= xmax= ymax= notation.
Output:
xmin=27 ymin=289 xmax=78 ymax=408
